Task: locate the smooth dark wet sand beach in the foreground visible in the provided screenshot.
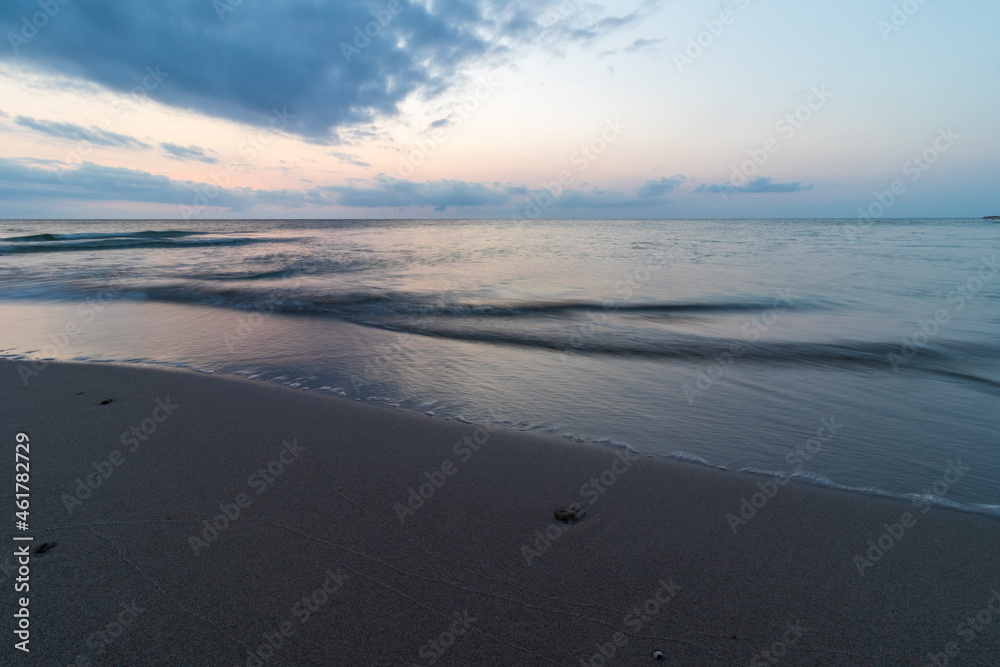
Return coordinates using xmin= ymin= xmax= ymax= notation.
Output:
xmin=0 ymin=362 xmax=1000 ymax=665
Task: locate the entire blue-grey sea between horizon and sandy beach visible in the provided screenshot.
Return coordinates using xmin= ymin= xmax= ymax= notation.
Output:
xmin=0 ymin=219 xmax=1000 ymax=516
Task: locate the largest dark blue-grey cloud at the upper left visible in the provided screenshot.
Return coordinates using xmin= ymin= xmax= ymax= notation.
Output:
xmin=0 ymin=0 xmax=656 ymax=141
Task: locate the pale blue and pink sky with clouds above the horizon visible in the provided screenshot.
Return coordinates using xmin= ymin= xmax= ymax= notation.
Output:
xmin=0 ymin=0 xmax=1000 ymax=219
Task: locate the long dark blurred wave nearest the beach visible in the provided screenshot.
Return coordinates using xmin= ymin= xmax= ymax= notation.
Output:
xmin=1 ymin=278 xmax=1000 ymax=378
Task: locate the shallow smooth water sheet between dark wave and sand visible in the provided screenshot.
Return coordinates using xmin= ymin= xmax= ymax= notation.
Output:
xmin=0 ymin=284 xmax=1000 ymax=514
